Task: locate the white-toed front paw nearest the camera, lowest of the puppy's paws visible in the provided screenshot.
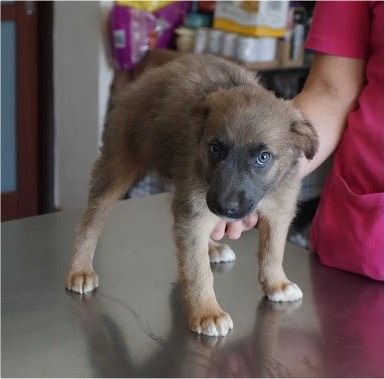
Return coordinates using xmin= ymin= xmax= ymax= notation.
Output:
xmin=189 ymin=311 xmax=233 ymax=337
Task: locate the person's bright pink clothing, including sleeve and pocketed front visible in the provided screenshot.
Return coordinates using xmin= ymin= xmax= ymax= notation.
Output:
xmin=306 ymin=1 xmax=384 ymax=280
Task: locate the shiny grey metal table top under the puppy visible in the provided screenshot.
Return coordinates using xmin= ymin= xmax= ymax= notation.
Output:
xmin=1 ymin=194 xmax=384 ymax=377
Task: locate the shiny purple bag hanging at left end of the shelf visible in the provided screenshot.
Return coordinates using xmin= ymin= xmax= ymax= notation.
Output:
xmin=110 ymin=1 xmax=191 ymax=70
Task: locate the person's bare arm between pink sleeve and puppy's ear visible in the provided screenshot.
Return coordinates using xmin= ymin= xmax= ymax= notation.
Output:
xmin=294 ymin=54 xmax=364 ymax=178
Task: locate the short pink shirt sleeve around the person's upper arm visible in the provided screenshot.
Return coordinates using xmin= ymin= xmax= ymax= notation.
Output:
xmin=306 ymin=1 xmax=370 ymax=59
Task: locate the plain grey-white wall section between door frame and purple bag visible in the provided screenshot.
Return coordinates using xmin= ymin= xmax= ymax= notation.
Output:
xmin=53 ymin=1 xmax=112 ymax=209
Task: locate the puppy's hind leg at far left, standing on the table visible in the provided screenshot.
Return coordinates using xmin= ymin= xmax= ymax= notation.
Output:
xmin=66 ymin=154 xmax=138 ymax=293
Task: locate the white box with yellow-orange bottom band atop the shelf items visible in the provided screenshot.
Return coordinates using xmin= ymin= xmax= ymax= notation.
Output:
xmin=213 ymin=1 xmax=289 ymax=38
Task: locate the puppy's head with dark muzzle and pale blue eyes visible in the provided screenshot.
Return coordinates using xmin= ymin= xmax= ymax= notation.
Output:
xmin=195 ymin=85 xmax=318 ymax=219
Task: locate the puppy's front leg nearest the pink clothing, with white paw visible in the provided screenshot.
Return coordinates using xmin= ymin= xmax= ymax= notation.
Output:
xmin=258 ymin=201 xmax=302 ymax=301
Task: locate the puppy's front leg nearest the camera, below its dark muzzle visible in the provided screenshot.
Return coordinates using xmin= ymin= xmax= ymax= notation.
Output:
xmin=173 ymin=195 xmax=233 ymax=336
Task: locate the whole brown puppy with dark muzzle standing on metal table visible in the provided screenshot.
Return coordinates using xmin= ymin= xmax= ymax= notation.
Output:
xmin=66 ymin=55 xmax=318 ymax=335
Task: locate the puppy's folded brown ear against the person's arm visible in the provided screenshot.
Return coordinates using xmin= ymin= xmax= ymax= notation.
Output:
xmin=290 ymin=120 xmax=319 ymax=160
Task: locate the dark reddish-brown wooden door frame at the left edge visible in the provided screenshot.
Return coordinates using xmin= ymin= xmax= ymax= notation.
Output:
xmin=1 ymin=2 xmax=54 ymax=221
